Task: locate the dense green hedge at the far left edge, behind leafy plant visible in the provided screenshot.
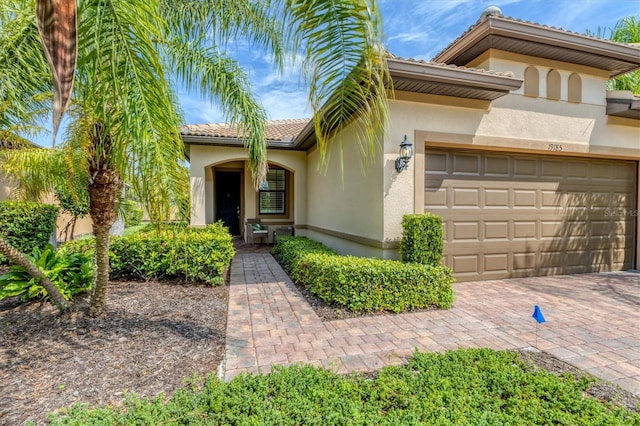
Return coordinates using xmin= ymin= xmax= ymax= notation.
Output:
xmin=0 ymin=201 xmax=58 ymax=263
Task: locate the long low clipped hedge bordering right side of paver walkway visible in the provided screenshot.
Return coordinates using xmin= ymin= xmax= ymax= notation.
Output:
xmin=273 ymin=237 xmax=454 ymax=312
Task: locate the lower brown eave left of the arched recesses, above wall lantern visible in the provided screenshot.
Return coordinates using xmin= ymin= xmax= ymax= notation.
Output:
xmin=387 ymin=58 xmax=522 ymax=101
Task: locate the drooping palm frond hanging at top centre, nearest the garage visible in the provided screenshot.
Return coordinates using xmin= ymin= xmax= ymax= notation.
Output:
xmin=276 ymin=0 xmax=391 ymax=170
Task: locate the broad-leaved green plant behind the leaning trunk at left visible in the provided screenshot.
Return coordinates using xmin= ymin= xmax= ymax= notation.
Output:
xmin=0 ymin=244 xmax=93 ymax=301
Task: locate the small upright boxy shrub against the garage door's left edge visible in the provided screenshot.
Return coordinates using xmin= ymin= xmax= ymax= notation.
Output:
xmin=400 ymin=213 xmax=444 ymax=266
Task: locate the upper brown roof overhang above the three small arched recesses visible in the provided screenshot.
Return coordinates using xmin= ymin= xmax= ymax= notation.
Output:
xmin=434 ymin=16 xmax=640 ymax=78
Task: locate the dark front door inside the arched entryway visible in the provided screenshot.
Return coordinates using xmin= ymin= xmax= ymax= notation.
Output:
xmin=216 ymin=171 xmax=242 ymax=235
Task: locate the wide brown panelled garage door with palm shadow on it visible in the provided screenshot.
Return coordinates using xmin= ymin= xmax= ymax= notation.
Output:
xmin=425 ymin=149 xmax=637 ymax=281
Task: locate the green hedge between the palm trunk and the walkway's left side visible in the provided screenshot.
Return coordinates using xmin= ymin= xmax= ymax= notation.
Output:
xmin=61 ymin=223 xmax=235 ymax=285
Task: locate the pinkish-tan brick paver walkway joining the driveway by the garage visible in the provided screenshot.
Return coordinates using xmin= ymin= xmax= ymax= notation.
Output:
xmin=221 ymin=253 xmax=640 ymax=394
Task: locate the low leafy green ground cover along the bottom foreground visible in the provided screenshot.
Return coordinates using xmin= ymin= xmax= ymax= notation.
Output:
xmin=51 ymin=349 xmax=640 ymax=425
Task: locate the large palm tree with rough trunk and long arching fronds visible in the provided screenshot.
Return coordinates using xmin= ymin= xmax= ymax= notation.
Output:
xmin=0 ymin=0 xmax=387 ymax=315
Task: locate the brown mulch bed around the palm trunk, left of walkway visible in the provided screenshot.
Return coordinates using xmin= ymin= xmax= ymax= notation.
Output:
xmin=0 ymin=281 xmax=229 ymax=425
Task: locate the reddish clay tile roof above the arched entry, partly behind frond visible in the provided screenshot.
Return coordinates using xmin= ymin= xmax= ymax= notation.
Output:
xmin=180 ymin=118 xmax=310 ymax=142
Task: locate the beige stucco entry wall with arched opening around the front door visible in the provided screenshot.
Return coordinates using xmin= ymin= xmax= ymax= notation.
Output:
xmin=189 ymin=145 xmax=307 ymax=230
